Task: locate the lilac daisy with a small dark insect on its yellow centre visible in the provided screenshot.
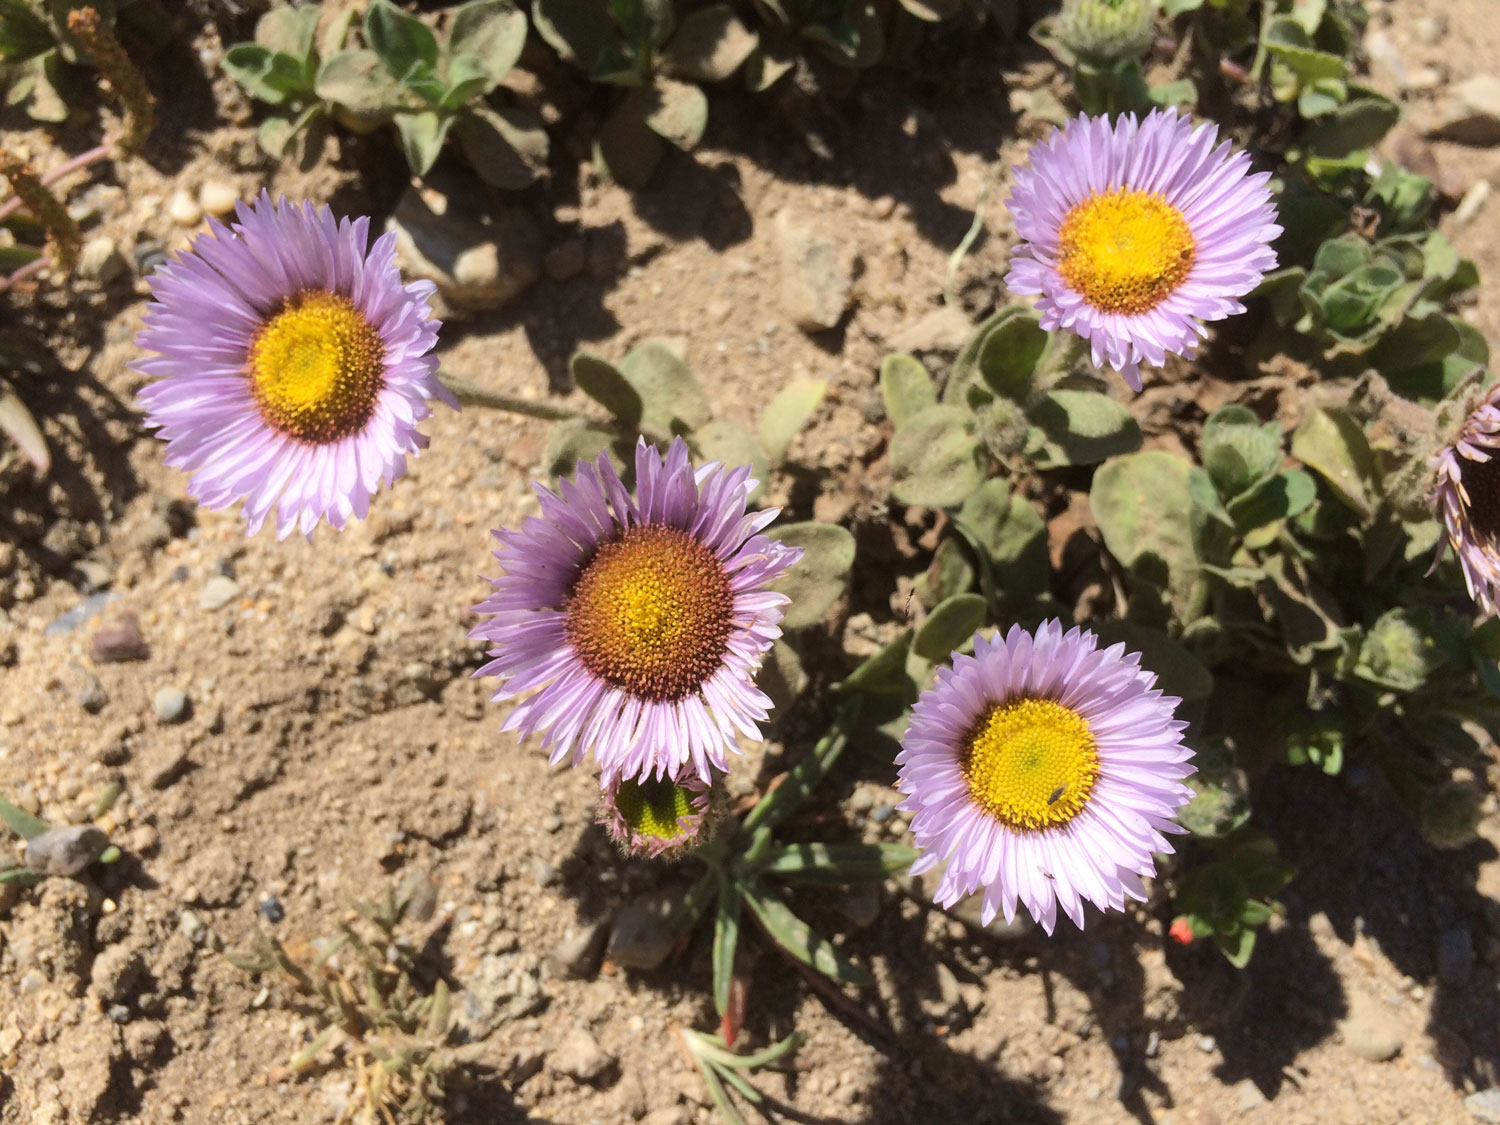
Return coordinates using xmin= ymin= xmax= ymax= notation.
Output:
xmin=896 ymin=621 xmax=1193 ymax=933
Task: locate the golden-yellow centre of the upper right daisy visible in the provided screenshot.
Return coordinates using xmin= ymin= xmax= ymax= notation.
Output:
xmin=1058 ymin=188 xmax=1194 ymax=315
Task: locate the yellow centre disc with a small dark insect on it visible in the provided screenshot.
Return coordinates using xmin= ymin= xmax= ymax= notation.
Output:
xmin=959 ymin=698 xmax=1100 ymax=831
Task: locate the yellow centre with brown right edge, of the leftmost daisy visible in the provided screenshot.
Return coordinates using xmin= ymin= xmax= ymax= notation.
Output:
xmin=246 ymin=291 xmax=386 ymax=444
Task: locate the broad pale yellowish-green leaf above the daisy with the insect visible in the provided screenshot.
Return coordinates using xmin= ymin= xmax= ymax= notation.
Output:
xmin=1089 ymin=450 xmax=1202 ymax=623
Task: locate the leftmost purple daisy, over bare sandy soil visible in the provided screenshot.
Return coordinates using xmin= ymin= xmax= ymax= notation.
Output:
xmin=132 ymin=192 xmax=458 ymax=539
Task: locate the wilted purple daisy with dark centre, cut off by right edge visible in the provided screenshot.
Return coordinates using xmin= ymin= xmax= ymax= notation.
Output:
xmin=1433 ymin=384 xmax=1500 ymax=614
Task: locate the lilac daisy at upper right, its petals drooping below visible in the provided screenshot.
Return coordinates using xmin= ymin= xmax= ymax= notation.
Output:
xmin=1005 ymin=110 xmax=1281 ymax=390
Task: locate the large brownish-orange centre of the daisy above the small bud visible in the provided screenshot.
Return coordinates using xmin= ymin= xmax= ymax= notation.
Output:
xmin=567 ymin=524 xmax=735 ymax=701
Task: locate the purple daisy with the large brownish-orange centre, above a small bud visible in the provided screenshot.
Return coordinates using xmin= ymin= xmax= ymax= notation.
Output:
xmin=471 ymin=438 xmax=803 ymax=782
